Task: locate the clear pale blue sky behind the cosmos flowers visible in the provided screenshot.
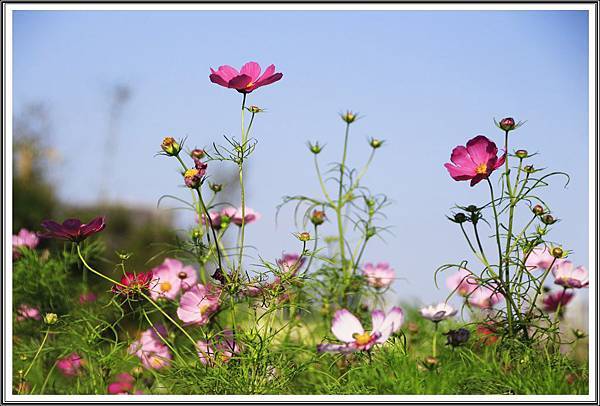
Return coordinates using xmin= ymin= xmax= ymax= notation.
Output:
xmin=14 ymin=11 xmax=589 ymax=308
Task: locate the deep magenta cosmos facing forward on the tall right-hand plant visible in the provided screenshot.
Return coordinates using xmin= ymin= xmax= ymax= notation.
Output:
xmin=444 ymin=135 xmax=506 ymax=186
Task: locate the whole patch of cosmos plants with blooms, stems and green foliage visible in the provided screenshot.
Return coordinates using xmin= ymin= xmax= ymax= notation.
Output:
xmin=12 ymin=62 xmax=589 ymax=395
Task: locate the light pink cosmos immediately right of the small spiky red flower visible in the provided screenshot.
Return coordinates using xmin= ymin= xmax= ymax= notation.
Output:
xmin=150 ymin=258 xmax=198 ymax=300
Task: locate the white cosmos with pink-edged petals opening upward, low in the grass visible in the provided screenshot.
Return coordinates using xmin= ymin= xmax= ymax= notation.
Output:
xmin=317 ymin=307 xmax=404 ymax=353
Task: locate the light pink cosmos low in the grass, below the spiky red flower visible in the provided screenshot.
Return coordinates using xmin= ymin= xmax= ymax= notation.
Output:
xmin=129 ymin=325 xmax=173 ymax=369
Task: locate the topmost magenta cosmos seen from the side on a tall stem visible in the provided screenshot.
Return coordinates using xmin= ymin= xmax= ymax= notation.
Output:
xmin=209 ymin=62 xmax=283 ymax=93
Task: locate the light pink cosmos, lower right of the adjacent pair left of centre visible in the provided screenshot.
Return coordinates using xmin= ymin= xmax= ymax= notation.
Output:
xmin=177 ymin=284 xmax=220 ymax=326
